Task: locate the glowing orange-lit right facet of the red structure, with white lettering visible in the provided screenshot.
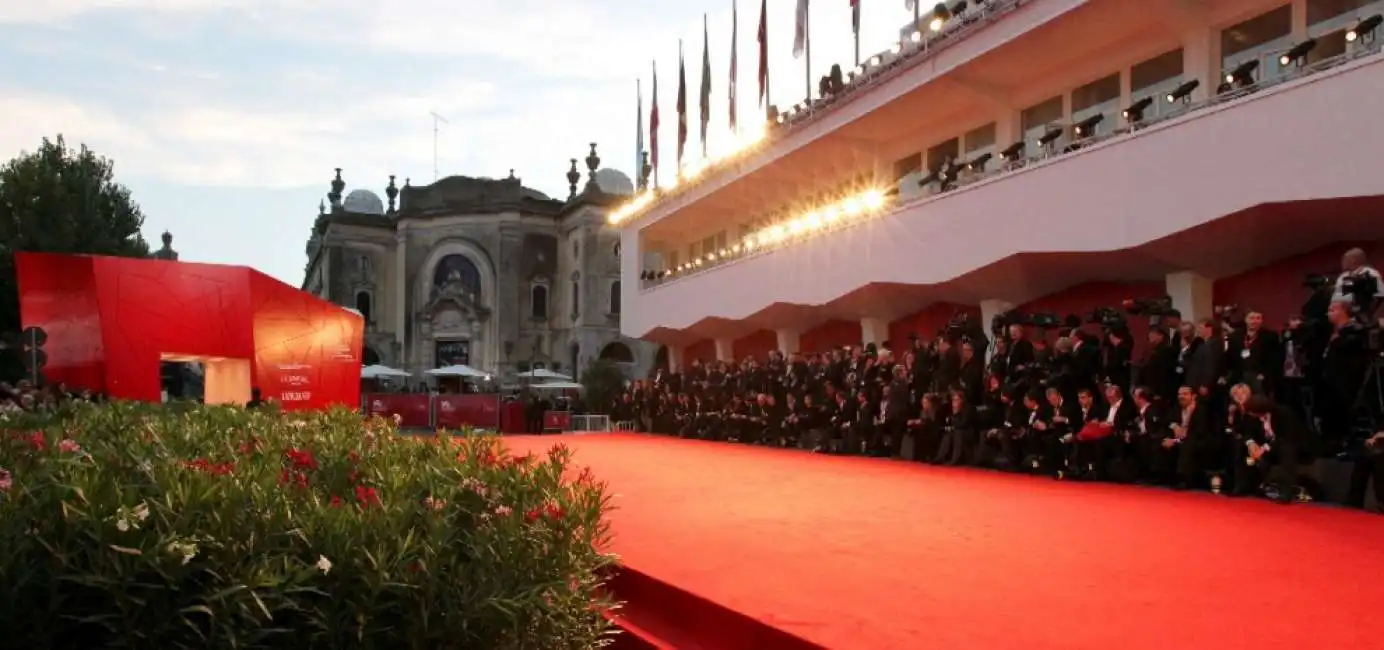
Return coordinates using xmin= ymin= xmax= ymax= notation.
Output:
xmin=249 ymin=271 xmax=364 ymax=411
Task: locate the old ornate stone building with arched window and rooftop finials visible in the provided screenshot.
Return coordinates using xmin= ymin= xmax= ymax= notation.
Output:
xmin=303 ymin=144 xmax=666 ymax=380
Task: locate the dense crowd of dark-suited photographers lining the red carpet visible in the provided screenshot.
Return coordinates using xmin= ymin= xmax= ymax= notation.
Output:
xmin=612 ymin=250 xmax=1384 ymax=506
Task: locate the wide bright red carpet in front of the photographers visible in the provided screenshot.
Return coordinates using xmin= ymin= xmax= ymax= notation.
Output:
xmin=507 ymin=434 xmax=1384 ymax=650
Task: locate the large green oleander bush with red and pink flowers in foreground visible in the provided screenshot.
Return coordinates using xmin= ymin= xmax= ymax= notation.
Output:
xmin=0 ymin=402 xmax=614 ymax=650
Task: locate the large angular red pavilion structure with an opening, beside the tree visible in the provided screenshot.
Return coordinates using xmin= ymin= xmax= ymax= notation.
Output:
xmin=17 ymin=253 xmax=363 ymax=409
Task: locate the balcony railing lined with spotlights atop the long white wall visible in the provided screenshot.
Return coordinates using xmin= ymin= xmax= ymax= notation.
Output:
xmin=639 ymin=39 xmax=1384 ymax=293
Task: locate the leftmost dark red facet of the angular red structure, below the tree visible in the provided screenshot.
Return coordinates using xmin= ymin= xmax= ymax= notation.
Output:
xmin=15 ymin=253 xmax=105 ymax=391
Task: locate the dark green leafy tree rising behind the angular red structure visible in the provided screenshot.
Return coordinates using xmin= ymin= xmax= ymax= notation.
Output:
xmin=0 ymin=136 xmax=149 ymax=378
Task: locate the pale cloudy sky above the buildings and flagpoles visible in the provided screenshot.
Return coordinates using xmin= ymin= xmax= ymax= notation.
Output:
xmin=8 ymin=0 xmax=912 ymax=285
